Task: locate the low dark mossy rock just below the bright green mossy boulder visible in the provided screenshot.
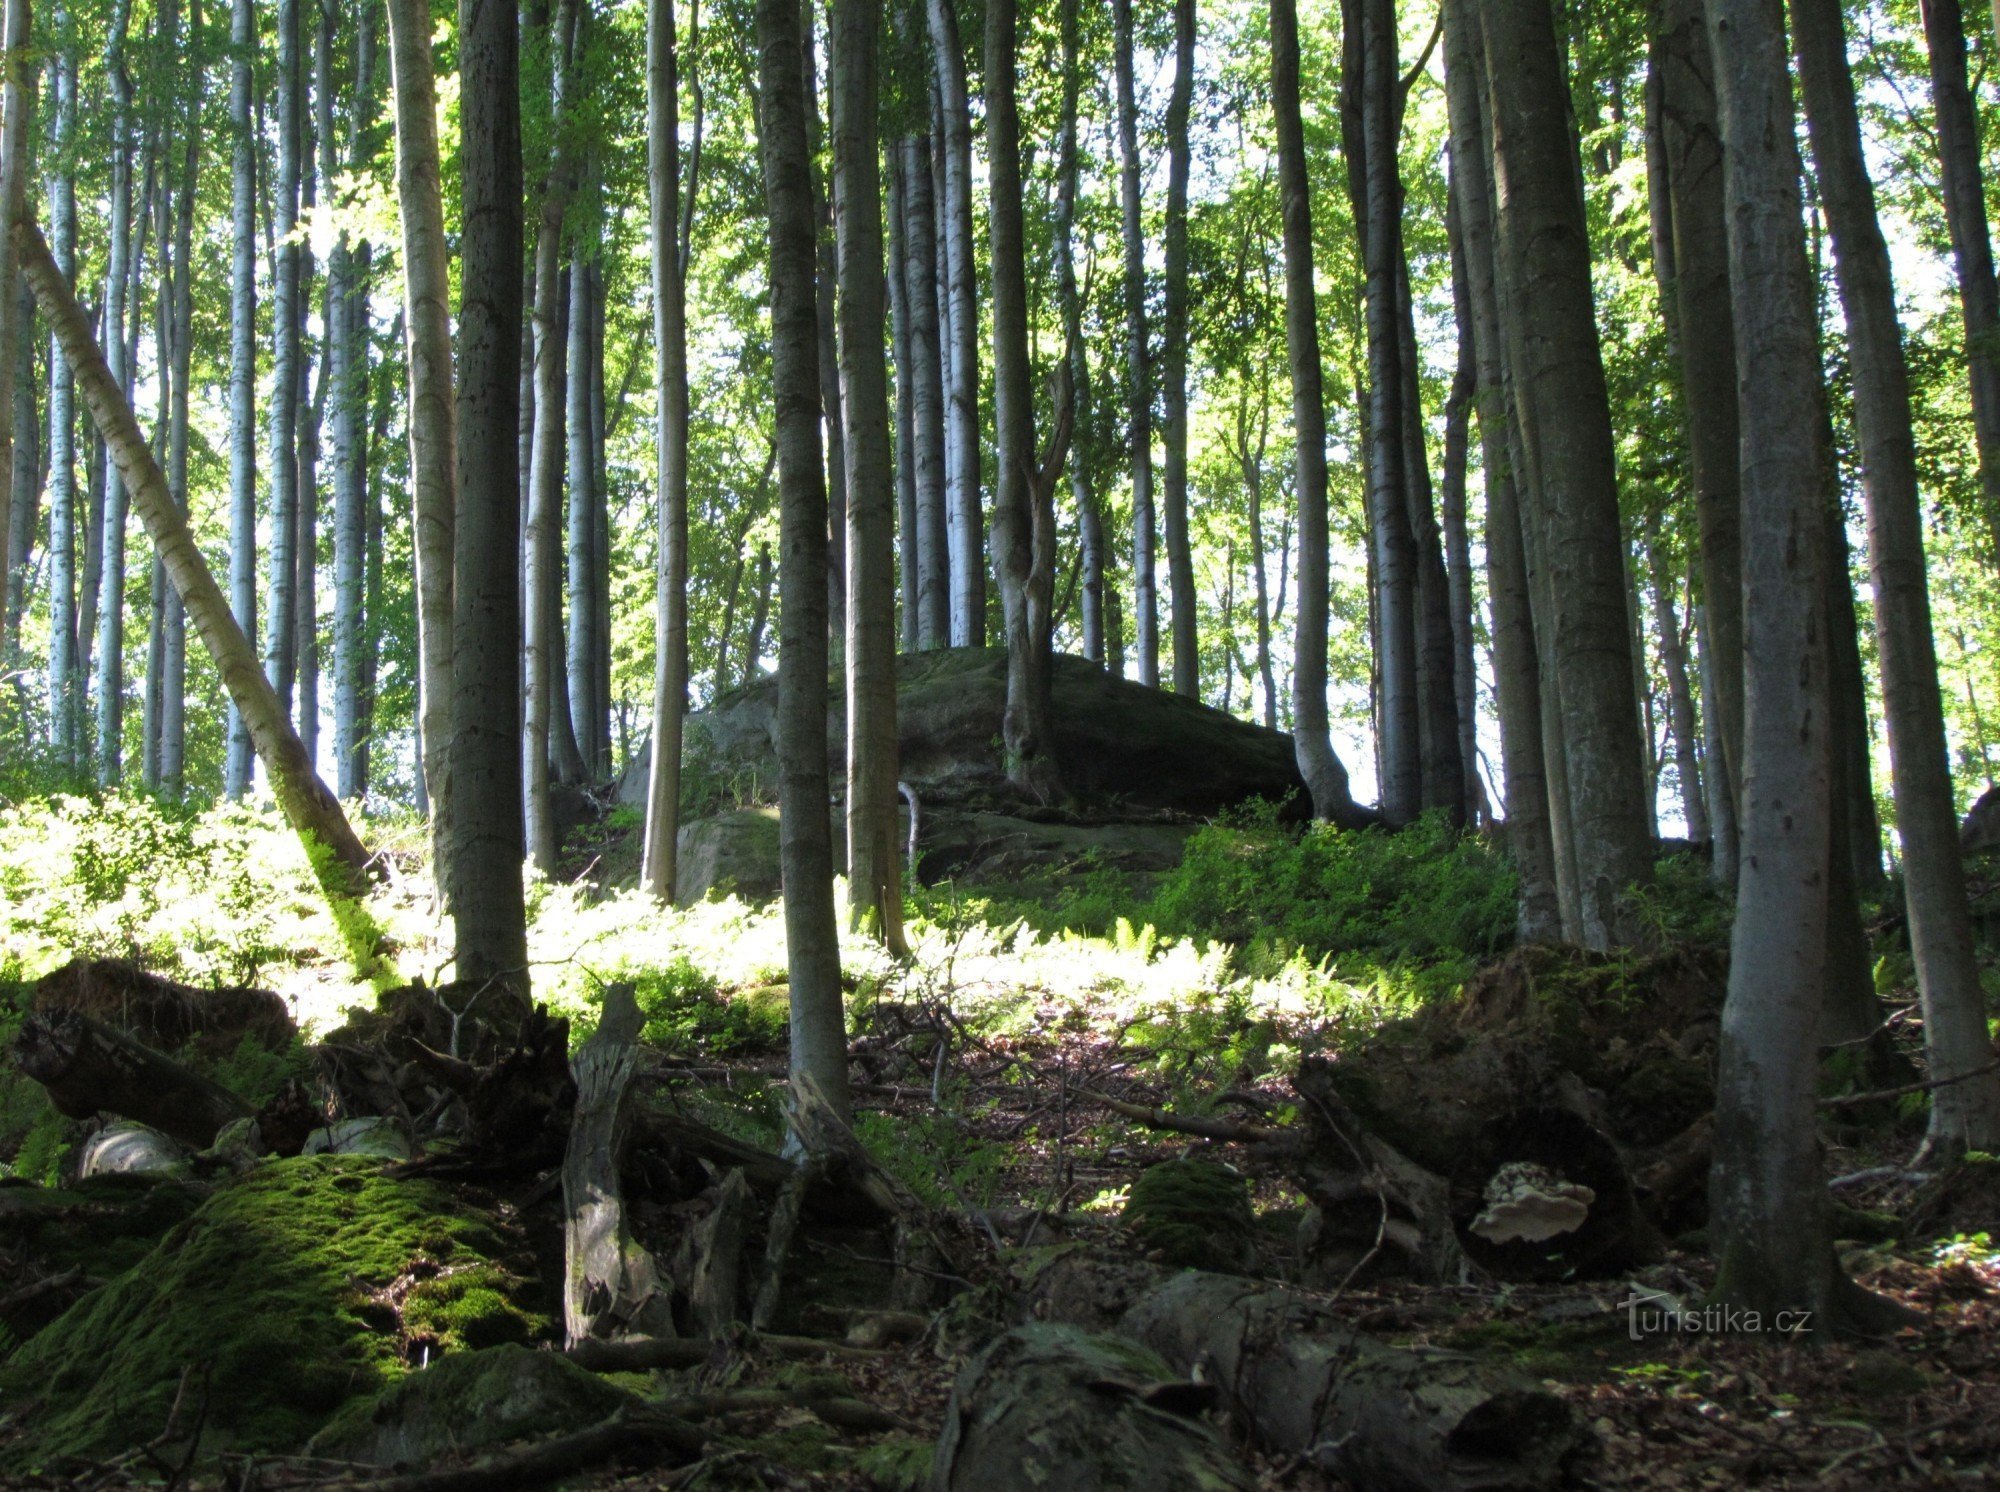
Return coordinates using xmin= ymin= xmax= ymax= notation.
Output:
xmin=310 ymin=1344 xmax=634 ymax=1466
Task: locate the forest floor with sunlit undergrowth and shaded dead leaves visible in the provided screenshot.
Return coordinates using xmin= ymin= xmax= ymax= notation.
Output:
xmin=0 ymin=792 xmax=2000 ymax=1492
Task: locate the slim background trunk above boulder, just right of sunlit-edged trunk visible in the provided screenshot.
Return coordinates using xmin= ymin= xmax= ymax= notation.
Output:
xmin=898 ymin=136 xmax=952 ymax=652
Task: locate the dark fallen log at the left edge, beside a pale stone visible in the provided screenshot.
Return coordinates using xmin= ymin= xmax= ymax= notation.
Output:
xmin=14 ymin=1010 xmax=252 ymax=1150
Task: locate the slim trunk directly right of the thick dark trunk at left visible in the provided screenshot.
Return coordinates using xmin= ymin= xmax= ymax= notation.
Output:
xmin=520 ymin=0 xmax=588 ymax=876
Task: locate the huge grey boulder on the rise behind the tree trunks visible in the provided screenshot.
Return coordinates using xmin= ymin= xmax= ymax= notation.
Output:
xmin=618 ymin=648 xmax=1306 ymax=818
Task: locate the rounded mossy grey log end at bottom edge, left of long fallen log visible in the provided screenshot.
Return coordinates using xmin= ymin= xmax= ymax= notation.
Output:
xmin=930 ymin=1322 xmax=1256 ymax=1492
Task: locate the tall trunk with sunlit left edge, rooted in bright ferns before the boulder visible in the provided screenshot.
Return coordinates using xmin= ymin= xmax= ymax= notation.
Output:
xmin=828 ymin=4 xmax=912 ymax=940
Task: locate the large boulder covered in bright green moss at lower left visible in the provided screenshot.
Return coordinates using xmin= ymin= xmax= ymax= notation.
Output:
xmin=0 ymin=1156 xmax=546 ymax=1470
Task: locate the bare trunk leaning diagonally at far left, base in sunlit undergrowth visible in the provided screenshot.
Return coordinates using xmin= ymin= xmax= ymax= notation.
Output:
xmin=14 ymin=220 xmax=370 ymax=910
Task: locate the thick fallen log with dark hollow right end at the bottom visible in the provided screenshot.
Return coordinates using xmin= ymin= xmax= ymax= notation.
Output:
xmin=1036 ymin=1254 xmax=1586 ymax=1492
